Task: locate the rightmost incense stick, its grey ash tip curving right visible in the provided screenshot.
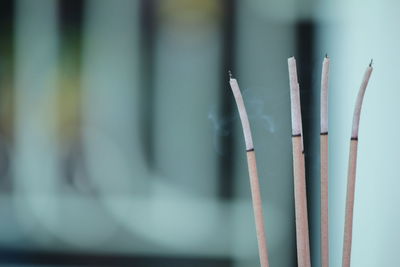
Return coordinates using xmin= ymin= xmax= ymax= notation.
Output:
xmin=342 ymin=60 xmax=373 ymax=267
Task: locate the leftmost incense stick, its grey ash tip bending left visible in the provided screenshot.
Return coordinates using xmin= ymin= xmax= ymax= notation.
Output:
xmin=229 ymin=72 xmax=269 ymax=267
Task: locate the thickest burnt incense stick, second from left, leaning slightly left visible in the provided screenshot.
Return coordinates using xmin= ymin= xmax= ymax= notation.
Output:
xmin=288 ymin=57 xmax=311 ymax=267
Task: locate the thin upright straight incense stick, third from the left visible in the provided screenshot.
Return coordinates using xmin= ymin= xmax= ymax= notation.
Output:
xmin=320 ymin=55 xmax=330 ymax=267
